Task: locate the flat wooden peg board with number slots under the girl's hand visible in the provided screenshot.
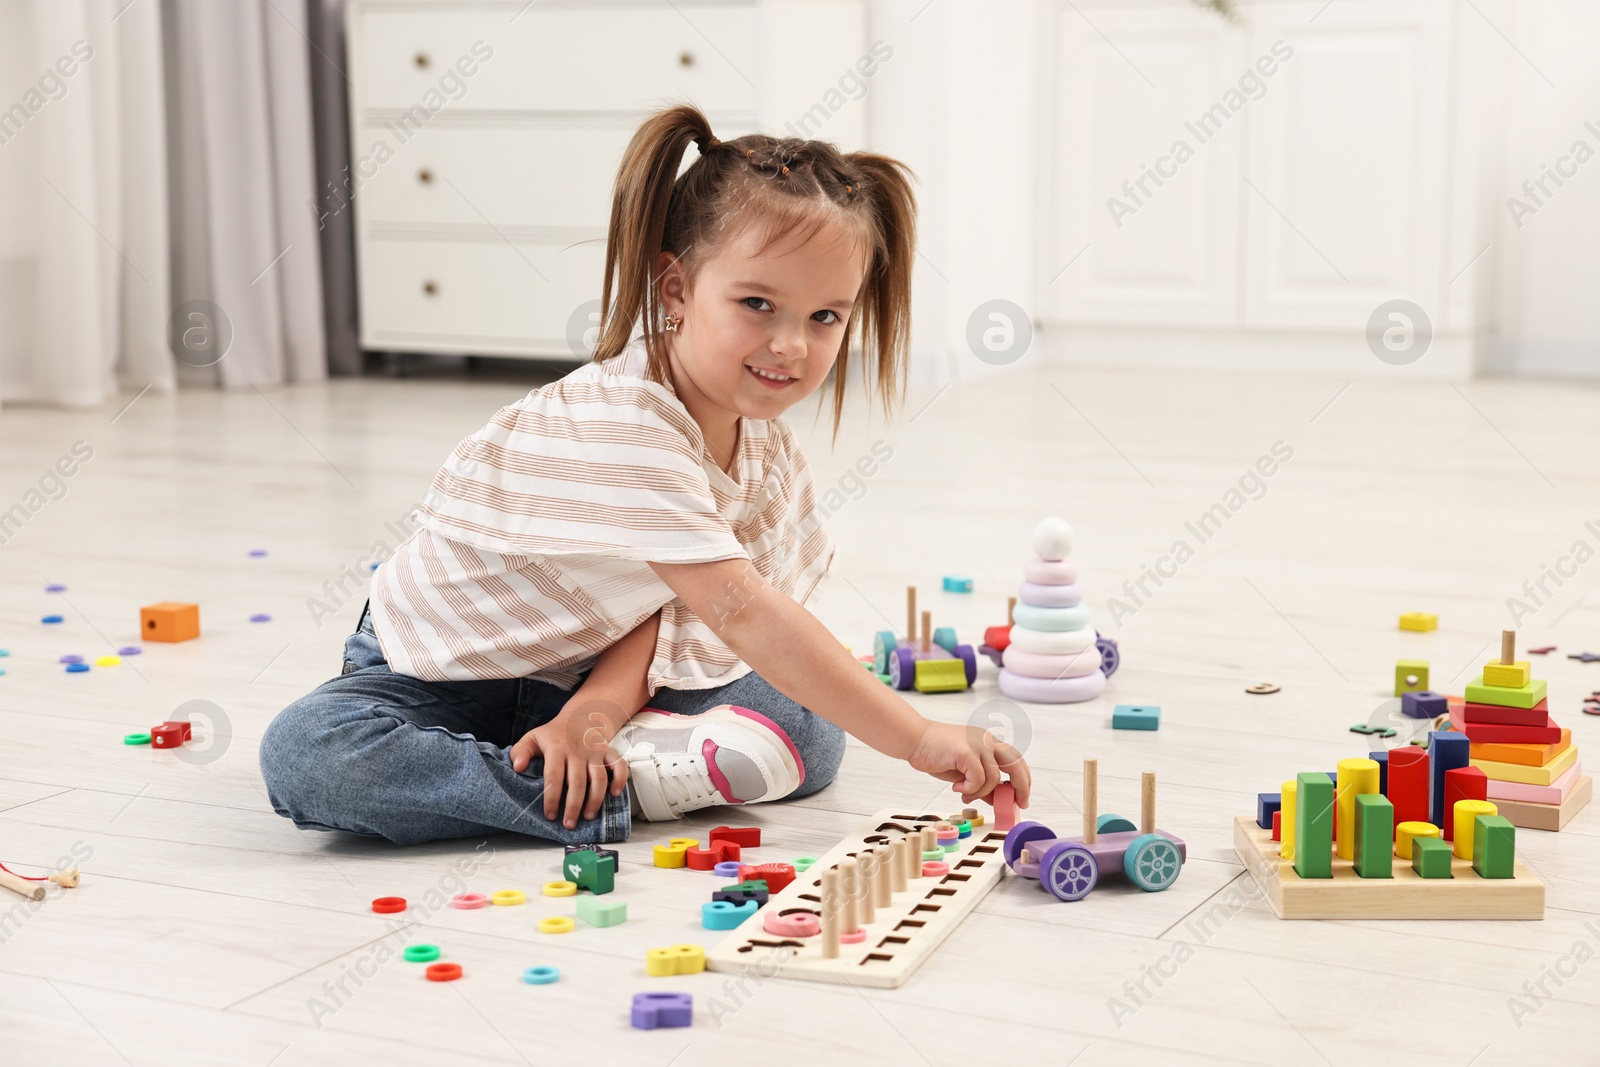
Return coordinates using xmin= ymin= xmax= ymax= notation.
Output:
xmin=706 ymin=808 xmax=1005 ymax=989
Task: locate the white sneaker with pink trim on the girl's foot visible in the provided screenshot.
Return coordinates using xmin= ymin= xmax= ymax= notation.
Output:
xmin=611 ymin=704 xmax=805 ymax=822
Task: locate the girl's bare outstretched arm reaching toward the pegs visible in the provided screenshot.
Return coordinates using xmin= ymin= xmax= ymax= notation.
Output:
xmin=650 ymin=558 xmax=1030 ymax=808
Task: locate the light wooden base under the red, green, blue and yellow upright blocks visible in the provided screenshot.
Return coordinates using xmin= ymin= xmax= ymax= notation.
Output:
xmin=1234 ymin=816 xmax=1544 ymax=918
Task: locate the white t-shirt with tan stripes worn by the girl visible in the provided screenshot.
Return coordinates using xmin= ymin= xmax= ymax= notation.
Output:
xmin=371 ymin=339 xmax=835 ymax=693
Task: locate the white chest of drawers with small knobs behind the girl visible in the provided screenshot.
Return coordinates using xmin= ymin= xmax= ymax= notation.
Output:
xmin=346 ymin=0 xmax=882 ymax=358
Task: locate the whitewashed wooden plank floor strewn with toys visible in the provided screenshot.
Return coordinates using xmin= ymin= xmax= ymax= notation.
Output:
xmin=0 ymin=366 xmax=1600 ymax=1067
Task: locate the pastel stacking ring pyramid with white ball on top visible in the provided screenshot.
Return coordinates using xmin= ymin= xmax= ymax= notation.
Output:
xmin=1000 ymin=517 xmax=1106 ymax=704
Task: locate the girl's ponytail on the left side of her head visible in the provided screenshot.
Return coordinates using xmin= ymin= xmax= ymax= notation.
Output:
xmin=594 ymin=104 xmax=712 ymax=382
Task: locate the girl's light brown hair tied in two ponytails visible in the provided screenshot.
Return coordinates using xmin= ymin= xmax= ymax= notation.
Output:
xmin=594 ymin=104 xmax=917 ymax=438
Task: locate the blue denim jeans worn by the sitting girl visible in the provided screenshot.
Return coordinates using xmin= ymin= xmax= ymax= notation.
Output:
xmin=261 ymin=609 xmax=845 ymax=845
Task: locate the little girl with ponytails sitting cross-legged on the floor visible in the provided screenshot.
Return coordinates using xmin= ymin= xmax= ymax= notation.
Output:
xmin=261 ymin=106 xmax=1029 ymax=843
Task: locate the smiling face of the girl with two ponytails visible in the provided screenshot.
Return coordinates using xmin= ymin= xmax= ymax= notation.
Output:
xmin=659 ymin=217 xmax=867 ymax=438
